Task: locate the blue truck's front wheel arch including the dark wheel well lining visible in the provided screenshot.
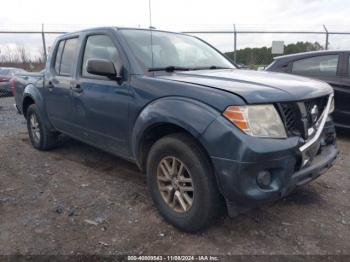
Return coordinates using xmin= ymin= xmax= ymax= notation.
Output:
xmin=131 ymin=97 xmax=220 ymax=170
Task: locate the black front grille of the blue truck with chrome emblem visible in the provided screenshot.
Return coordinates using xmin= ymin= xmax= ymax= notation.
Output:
xmin=278 ymin=96 xmax=328 ymax=139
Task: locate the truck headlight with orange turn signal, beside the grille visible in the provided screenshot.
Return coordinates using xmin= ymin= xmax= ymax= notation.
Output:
xmin=223 ymin=105 xmax=287 ymax=138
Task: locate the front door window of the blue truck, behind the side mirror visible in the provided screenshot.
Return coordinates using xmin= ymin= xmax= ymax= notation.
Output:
xmin=82 ymin=35 xmax=119 ymax=79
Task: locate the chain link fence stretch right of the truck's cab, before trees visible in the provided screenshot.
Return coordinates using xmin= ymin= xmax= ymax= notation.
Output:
xmin=183 ymin=25 xmax=350 ymax=69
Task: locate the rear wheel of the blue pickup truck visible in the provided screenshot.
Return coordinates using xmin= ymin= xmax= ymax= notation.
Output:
xmin=27 ymin=104 xmax=58 ymax=150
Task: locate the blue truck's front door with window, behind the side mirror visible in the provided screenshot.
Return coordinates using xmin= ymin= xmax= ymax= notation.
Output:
xmin=72 ymin=33 xmax=130 ymax=156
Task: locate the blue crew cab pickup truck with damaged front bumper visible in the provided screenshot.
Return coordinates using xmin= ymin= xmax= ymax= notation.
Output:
xmin=15 ymin=27 xmax=338 ymax=232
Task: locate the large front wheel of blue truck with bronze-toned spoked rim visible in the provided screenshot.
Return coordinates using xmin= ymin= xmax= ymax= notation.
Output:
xmin=147 ymin=133 xmax=225 ymax=232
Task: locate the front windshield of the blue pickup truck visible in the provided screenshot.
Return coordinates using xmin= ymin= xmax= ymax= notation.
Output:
xmin=120 ymin=29 xmax=235 ymax=69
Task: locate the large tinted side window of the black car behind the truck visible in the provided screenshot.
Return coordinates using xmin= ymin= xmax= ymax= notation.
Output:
xmin=292 ymin=55 xmax=339 ymax=76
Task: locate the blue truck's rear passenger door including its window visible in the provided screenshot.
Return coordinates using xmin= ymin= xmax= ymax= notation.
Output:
xmin=45 ymin=37 xmax=79 ymax=134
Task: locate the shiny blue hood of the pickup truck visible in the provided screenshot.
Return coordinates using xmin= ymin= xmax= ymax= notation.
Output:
xmin=158 ymin=69 xmax=332 ymax=104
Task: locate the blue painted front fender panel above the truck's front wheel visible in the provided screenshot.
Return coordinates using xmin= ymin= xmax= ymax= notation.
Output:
xmin=131 ymin=97 xmax=220 ymax=165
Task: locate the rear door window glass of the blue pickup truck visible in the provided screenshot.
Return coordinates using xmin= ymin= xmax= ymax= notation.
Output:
xmin=59 ymin=38 xmax=78 ymax=76
